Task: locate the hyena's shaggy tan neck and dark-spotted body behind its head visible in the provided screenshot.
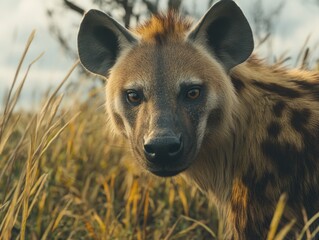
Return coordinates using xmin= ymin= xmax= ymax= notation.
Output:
xmin=185 ymin=55 xmax=319 ymax=236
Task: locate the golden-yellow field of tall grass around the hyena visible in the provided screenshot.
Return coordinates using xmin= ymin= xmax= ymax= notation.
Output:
xmin=0 ymin=32 xmax=318 ymax=239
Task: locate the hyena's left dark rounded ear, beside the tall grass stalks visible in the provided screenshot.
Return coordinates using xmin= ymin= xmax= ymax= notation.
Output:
xmin=78 ymin=10 xmax=137 ymax=77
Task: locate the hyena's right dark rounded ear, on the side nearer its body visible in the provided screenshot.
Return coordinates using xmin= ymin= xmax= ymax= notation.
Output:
xmin=188 ymin=0 xmax=254 ymax=71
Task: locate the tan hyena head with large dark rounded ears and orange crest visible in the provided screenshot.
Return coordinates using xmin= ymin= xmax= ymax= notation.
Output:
xmin=78 ymin=0 xmax=253 ymax=176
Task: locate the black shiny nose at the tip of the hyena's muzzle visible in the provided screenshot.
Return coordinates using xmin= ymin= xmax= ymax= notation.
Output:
xmin=144 ymin=136 xmax=183 ymax=163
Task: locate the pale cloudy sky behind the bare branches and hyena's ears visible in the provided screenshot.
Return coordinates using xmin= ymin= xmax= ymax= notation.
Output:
xmin=0 ymin=0 xmax=319 ymax=109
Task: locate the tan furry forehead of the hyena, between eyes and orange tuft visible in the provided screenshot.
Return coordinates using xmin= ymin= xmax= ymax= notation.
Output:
xmin=109 ymin=42 xmax=229 ymax=91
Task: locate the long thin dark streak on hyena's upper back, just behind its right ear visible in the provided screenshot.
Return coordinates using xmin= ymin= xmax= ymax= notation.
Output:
xmin=253 ymin=80 xmax=301 ymax=98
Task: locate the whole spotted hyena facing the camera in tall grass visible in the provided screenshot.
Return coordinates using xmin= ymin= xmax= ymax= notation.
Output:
xmin=78 ymin=0 xmax=319 ymax=239
